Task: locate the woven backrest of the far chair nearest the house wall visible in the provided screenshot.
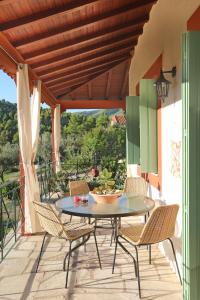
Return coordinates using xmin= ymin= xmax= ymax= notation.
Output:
xmin=124 ymin=177 xmax=147 ymax=196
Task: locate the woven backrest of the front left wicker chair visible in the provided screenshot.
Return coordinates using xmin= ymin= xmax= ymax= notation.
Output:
xmin=33 ymin=201 xmax=67 ymax=238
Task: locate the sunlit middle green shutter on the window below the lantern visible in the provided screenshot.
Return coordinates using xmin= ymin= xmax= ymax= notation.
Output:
xmin=140 ymin=79 xmax=158 ymax=173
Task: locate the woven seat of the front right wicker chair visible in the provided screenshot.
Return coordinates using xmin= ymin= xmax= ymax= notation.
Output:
xmin=119 ymin=224 xmax=144 ymax=244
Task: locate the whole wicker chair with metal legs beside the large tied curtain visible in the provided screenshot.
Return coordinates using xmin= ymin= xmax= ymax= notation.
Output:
xmin=33 ymin=202 xmax=101 ymax=288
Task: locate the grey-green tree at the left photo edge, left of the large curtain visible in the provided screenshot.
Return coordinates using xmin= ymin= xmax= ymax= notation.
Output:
xmin=0 ymin=143 xmax=19 ymax=183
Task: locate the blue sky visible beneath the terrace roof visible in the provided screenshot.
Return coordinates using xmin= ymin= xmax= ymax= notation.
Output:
xmin=0 ymin=70 xmax=95 ymax=112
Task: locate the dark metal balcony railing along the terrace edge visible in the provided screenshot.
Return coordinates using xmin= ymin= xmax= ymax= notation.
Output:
xmin=0 ymin=161 xmax=126 ymax=261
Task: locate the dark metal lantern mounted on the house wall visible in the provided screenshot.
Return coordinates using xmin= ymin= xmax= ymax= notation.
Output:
xmin=155 ymin=67 xmax=176 ymax=101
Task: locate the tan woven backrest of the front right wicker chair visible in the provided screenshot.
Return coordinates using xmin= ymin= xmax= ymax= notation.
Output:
xmin=138 ymin=204 xmax=179 ymax=244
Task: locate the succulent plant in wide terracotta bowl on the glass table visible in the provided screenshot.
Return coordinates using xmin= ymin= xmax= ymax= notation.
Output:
xmin=91 ymin=169 xmax=122 ymax=203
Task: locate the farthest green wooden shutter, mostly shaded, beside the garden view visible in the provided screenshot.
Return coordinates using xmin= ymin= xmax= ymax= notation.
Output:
xmin=126 ymin=96 xmax=140 ymax=164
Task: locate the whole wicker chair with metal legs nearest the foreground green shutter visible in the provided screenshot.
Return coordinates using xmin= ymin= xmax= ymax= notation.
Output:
xmin=112 ymin=204 xmax=182 ymax=298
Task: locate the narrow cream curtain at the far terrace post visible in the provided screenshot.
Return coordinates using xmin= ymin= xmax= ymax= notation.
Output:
xmin=54 ymin=104 xmax=61 ymax=173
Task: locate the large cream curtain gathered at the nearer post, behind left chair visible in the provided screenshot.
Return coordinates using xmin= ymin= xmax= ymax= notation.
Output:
xmin=17 ymin=65 xmax=41 ymax=233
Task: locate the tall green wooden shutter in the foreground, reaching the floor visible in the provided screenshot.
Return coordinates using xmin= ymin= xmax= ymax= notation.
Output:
xmin=182 ymin=32 xmax=200 ymax=300
